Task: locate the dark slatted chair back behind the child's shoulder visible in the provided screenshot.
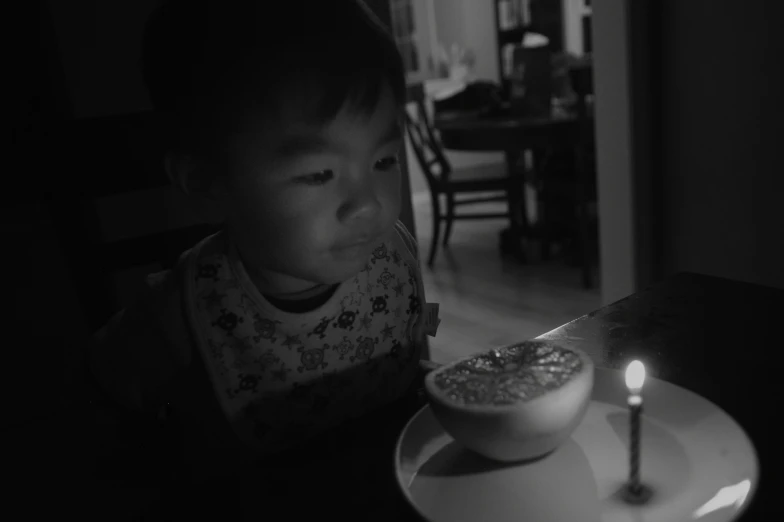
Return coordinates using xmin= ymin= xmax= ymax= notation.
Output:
xmin=33 ymin=112 xmax=214 ymax=331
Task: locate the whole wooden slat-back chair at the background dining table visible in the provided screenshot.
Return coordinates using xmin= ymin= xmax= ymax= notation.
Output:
xmin=406 ymin=89 xmax=514 ymax=267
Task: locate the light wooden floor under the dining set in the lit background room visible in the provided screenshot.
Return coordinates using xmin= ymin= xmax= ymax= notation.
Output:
xmin=414 ymin=193 xmax=600 ymax=363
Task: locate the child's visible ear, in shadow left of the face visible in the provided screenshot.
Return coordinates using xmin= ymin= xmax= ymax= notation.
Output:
xmin=164 ymin=152 xmax=225 ymax=223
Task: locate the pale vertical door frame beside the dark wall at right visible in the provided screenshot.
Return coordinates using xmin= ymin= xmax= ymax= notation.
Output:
xmin=592 ymin=0 xmax=661 ymax=305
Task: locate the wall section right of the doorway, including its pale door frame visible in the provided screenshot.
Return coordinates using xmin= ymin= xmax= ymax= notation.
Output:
xmin=593 ymin=0 xmax=784 ymax=303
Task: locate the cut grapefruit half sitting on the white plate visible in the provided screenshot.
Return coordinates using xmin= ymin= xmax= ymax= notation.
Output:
xmin=425 ymin=339 xmax=594 ymax=462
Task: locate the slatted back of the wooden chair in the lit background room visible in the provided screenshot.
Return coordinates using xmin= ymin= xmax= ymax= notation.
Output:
xmin=406 ymin=89 xmax=452 ymax=193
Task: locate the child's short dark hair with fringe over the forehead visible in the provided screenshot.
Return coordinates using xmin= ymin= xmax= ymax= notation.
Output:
xmin=142 ymin=0 xmax=405 ymax=158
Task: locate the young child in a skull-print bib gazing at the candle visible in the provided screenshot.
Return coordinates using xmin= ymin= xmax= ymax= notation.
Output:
xmin=90 ymin=0 xmax=438 ymax=512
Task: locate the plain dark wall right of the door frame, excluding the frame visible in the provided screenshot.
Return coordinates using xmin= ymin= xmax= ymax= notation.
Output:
xmin=656 ymin=0 xmax=784 ymax=288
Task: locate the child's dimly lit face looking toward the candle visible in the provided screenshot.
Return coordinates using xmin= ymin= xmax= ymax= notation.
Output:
xmin=216 ymin=87 xmax=403 ymax=294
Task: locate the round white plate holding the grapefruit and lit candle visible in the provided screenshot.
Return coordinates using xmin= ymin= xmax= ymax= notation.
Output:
xmin=395 ymin=368 xmax=758 ymax=522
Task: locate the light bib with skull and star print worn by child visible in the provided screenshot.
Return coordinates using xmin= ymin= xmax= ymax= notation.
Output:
xmin=185 ymin=223 xmax=423 ymax=453
